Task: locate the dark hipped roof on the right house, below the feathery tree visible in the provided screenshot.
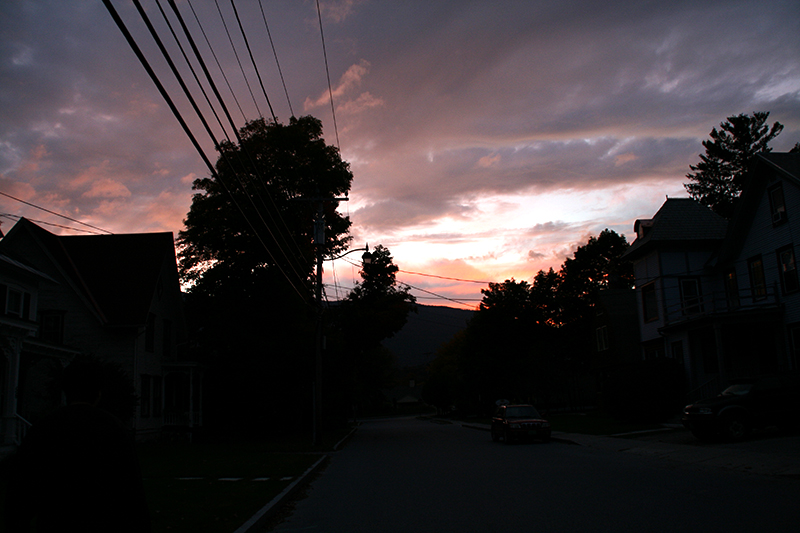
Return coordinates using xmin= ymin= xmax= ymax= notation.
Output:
xmin=624 ymin=198 xmax=728 ymax=259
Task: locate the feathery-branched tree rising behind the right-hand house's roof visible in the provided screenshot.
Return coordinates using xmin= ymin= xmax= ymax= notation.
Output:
xmin=684 ymin=112 xmax=783 ymax=218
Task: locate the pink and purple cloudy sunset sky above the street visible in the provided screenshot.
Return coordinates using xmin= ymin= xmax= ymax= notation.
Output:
xmin=0 ymin=0 xmax=800 ymax=308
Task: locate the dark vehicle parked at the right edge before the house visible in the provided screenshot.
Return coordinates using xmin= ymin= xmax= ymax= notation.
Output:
xmin=681 ymin=376 xmax=800 ymax=440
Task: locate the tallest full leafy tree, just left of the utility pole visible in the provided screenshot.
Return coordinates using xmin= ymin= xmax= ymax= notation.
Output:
xmin=178 ymin=117 xmax=353 ymax=431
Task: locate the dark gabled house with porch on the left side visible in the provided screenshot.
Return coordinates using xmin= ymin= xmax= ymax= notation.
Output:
xmin=0 ymin=218 xmax=202 ymax=440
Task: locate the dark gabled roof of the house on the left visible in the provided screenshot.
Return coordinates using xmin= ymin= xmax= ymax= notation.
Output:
xmin=0 ymin=218 xmax=175 ymax=326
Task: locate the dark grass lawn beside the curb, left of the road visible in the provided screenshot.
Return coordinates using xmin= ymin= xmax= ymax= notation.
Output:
xmin=139 ymin=429 xmax=349 ymax=533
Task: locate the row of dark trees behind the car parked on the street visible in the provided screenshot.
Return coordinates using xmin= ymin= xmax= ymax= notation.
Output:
xmin=424 ymin=229 xmax=674 ymax=420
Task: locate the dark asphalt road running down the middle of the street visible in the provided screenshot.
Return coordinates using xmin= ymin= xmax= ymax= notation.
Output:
xmin=273 ymin=419 xmax=800 ymax=533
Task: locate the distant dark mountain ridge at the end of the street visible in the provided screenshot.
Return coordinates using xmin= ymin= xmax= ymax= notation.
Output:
xmin=383 ymin=304 xmax=475 ymax=368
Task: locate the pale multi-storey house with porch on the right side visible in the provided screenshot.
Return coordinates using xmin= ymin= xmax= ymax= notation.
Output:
xmin=626 ymin=153 xmax=800 ymax=397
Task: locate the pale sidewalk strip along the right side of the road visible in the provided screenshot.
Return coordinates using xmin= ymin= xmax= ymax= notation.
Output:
xmin=462 ymin=423 xmax=800 ymax=478
